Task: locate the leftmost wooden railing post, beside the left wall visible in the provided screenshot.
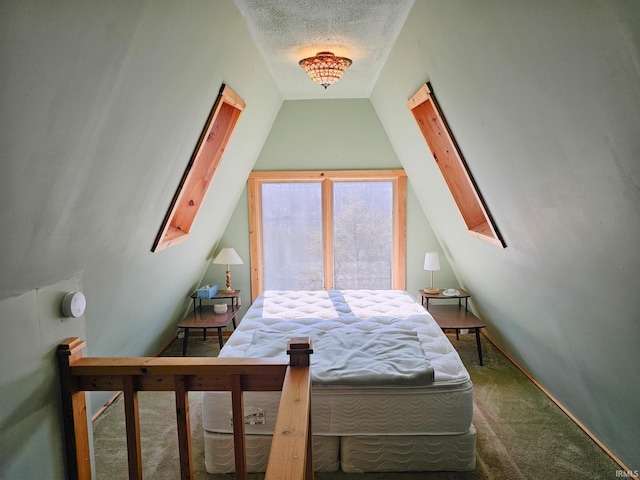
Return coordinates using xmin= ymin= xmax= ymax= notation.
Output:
xmin=57 ymin=338 xmax=91 ymax=480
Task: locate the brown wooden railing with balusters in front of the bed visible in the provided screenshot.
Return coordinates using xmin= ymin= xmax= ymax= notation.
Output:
xmin=58 ymin=338 xmax=313 ymax=480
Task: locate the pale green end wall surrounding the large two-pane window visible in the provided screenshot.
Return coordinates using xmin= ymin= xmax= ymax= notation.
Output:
xmin=200 ymin=99 xmax=458 ymax=305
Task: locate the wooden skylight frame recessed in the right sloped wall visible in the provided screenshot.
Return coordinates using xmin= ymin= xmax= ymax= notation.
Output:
xmin=407 ymin=82 xmax=506 ymax=248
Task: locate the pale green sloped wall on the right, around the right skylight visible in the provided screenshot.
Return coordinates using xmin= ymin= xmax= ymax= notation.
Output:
xmin=371 ymin=0 xmax=640 ymax=475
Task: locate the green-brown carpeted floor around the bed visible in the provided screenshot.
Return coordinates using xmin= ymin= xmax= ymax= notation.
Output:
xmin=94 ymin=335 xmax=620 ymax=480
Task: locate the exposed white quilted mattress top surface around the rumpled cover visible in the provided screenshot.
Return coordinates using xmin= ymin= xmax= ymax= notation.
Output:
xmin=219 ymin=290 xmax=470 ymax=387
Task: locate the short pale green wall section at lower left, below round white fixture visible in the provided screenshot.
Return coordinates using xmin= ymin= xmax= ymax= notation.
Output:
xmin=0 ymin=278 xmax=91 ymax=479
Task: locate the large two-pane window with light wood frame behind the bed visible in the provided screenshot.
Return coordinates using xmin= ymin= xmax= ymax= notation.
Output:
xmin=249 ymin=170 xmax=406 ymax=298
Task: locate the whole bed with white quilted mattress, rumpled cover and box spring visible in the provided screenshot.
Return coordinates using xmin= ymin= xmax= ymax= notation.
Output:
xmin=203 ymin=290 xmax=476 ymax=473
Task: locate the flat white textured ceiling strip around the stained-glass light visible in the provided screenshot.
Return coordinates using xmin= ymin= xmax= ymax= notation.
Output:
xmin=234 ymin=0 xmax=414 ymax=100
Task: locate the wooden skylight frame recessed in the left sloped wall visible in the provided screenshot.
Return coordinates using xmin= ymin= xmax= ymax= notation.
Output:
xmin=151 ymin=84 xmax=245 ymax=252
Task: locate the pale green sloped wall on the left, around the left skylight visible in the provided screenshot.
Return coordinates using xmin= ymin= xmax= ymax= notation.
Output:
xmin=0 ymin=0 xmax=282 ymax=479
